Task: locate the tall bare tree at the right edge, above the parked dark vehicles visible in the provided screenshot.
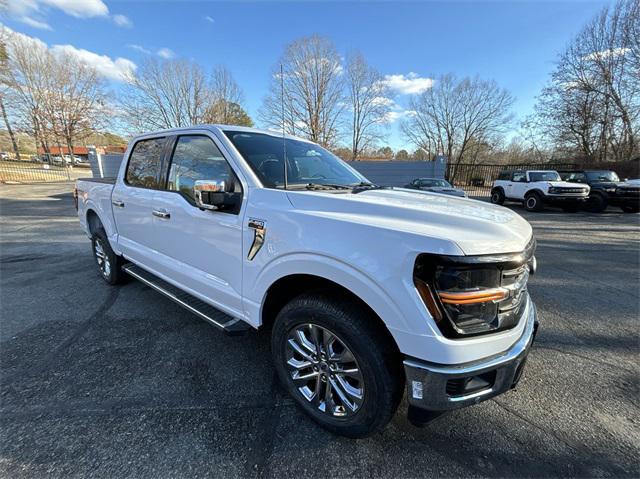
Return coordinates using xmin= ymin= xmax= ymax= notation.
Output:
xmin=536 ymin=0 xmax=640 ymax=161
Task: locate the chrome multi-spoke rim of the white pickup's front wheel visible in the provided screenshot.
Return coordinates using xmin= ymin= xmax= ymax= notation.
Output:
xmin=286 ymin=323 xmax=364 ymax=418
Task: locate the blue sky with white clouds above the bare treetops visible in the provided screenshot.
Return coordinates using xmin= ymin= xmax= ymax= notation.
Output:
xmin=4 ymin=0 xmax=609 ymax=149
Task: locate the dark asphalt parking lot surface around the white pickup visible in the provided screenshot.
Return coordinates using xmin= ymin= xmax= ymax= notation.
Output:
xmin=0 ymin=184 xmax=640 ymax=478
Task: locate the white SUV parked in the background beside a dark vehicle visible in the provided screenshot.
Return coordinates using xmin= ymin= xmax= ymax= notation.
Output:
xmin=491 ymin=170 xmax=590 ymax=212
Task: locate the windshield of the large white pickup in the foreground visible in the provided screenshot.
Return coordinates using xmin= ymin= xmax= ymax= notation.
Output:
xmin=224 ymin=131 xmax=368 ymax=188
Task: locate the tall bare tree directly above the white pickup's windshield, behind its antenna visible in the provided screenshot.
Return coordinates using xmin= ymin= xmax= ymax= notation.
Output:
xmin=260 ymin=35 xmax=345 ymax=147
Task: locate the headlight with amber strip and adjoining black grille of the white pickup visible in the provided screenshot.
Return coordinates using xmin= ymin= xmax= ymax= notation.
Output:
xmin=414 ymin=243 xmax=535 ymax=337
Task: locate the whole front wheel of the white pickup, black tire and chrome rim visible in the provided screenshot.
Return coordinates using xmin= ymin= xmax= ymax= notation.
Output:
xmin=271 ymin=295 xmax=404 ymax=438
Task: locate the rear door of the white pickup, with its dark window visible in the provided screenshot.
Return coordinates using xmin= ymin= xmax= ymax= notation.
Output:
xmin=111 ymin=137 xmax=166 ymax=268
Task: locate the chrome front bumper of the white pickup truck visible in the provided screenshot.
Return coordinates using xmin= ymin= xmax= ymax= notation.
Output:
xmin=404 ymin=300 xmax=538 ymax=412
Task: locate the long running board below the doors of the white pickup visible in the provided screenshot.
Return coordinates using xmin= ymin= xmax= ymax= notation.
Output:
xmin=122 ymin=263 xmax=251 ymax=336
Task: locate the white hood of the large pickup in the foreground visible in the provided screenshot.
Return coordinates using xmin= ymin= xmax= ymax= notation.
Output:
xmin=288 ymin=188 xmax=532 ymax=255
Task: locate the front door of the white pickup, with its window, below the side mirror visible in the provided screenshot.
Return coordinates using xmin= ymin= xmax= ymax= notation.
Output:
xmin=154 ymin=132 xmax=242 ymax=317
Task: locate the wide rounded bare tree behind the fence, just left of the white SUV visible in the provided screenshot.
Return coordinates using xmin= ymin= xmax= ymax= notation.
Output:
xmin=401 ymin=75 xmax=514 ymax=176
